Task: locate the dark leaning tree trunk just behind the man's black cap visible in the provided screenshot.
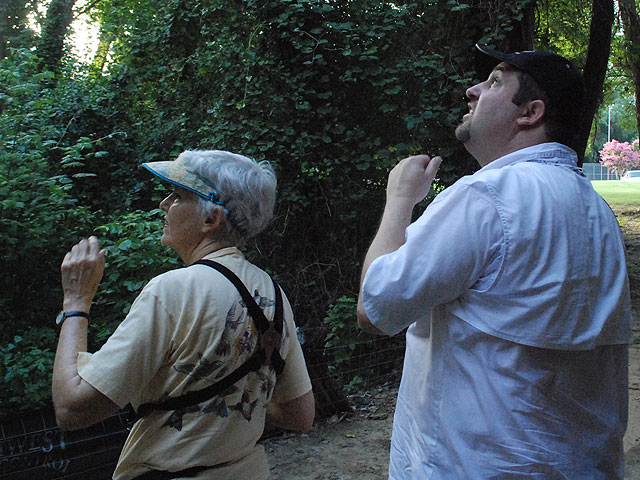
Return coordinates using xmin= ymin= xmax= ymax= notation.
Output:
xmin=573 ymin=0 xmax=614 ymax=166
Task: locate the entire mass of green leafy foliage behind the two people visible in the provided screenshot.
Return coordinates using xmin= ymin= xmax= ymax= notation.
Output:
xmin=0 ymin=0 xmax=527 ymax=408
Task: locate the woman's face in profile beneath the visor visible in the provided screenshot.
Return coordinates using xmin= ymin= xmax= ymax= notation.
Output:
xmin=160 ymin=186 xmax=204 ymax=260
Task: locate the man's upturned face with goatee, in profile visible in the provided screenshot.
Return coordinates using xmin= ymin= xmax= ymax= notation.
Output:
xmin=456 ymin=63 xmax=521 ymax=166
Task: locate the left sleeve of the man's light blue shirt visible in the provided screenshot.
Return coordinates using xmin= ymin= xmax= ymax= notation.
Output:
xmin=362 ymin=183 xmax=504 ymax=335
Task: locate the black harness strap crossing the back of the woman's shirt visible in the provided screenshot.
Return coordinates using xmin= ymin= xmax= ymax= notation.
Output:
xmin=136 ymin=260 xmax=285 ymax=418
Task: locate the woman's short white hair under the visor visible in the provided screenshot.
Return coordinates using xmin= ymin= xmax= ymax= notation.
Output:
xmin=179 ymin=150 xmax=277 ymax=245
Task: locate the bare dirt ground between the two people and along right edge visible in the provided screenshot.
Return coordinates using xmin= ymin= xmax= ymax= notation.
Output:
xmin=264 ymin=208 xmax=640 ymax=480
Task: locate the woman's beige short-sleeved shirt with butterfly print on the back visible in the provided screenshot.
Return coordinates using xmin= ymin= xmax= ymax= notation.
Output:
xmin=78 ymin=247 xmax=311 ymax=480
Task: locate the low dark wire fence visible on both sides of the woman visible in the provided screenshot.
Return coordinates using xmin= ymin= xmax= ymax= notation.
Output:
xmin=0 ymin=328 xmax=404 ymax=480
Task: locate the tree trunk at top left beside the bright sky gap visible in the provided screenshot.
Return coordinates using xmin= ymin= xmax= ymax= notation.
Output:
xmin=37 ymin=0 xmax=76 ymax=72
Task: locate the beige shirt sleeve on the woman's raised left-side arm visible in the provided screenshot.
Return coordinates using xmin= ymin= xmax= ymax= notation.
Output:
xmin=78 ymin=279 xmax=175 ymax=407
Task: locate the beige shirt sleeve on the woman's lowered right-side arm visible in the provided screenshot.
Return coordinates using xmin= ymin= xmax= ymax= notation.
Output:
xmin=271 ymin=295 xmax=311 ymax=403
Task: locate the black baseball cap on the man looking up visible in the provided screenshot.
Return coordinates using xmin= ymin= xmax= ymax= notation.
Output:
xmin=476 ymin=44 xmax=585 ymax=121
